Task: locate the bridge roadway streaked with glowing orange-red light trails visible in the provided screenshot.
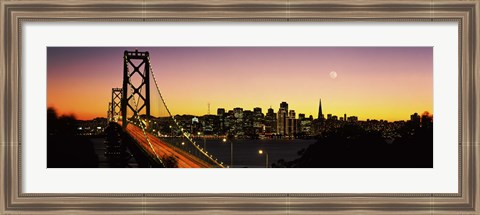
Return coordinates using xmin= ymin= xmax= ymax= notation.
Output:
xmin=118 ymin=122 xmax=211 ymax=168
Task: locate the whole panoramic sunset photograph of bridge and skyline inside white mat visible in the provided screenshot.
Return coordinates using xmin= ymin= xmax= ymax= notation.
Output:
xmin=46 ymin=47 xmax=434 ymax=168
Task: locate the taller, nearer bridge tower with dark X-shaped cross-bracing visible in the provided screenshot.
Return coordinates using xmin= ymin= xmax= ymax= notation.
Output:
xmin=121 ymin=50 xmax=150 ymax=128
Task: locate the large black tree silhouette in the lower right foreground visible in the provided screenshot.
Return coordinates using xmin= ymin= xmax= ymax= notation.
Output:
xmin=272 ymin=112 xmax=433 ymax=168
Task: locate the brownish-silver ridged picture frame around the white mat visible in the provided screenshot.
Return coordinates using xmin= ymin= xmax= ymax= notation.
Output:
xmin=0 ymin=0 xmax=480 ymax=214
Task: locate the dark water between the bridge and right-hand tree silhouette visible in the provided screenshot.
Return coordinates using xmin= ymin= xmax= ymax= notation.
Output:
xmin=195 ymin=138 xmax=315 ymax=168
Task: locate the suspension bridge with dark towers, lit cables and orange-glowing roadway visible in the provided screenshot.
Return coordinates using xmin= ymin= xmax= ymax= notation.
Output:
xmin=106 ymin=50 xmax=224 ymax=168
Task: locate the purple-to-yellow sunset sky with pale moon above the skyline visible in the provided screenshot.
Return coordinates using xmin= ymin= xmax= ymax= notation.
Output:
xmin=47 ymin=47 xmax=433 ymax=121
